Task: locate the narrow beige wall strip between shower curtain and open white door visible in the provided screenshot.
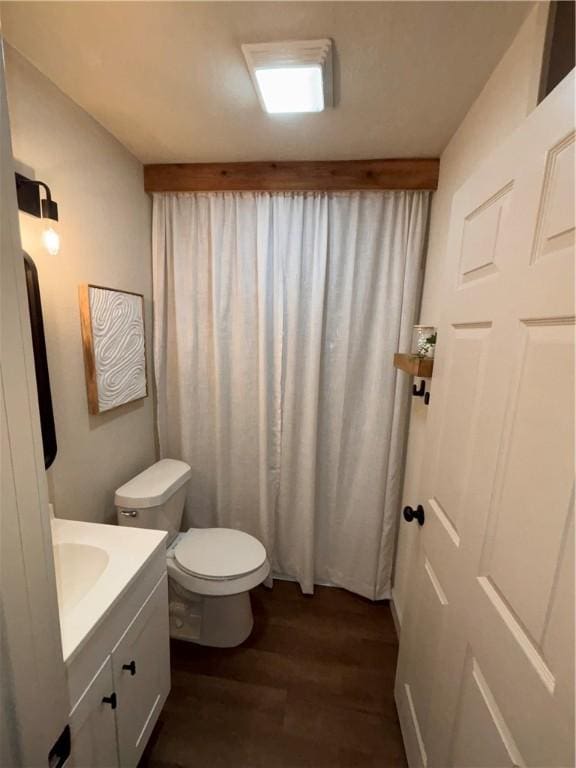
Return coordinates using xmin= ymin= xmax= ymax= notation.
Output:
xmin=393 ymin=2 xmax=548 ymax=622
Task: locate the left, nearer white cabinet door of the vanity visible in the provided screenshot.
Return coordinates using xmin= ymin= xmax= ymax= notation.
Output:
xmin=70 ymin=656 xmax=118 ymax=768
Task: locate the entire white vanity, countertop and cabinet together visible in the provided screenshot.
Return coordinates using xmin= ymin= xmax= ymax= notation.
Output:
xmin=52 ymin=519 xmax=170 ymax=768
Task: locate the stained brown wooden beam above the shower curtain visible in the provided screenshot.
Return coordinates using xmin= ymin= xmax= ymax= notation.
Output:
xmin=144 ymin=159 xmax=440 ymax=192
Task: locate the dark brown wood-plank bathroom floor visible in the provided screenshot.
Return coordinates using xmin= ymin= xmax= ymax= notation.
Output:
xmin=141 ymin=581 xmax=406 ymax=768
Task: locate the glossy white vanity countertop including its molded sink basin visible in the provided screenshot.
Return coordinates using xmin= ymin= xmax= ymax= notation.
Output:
xmin=52 ymin=518 xmax=167 ymax=662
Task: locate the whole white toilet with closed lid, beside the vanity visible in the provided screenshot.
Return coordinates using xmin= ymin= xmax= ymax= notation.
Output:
xmin=114 ymin=459 xmax=270 ymax=648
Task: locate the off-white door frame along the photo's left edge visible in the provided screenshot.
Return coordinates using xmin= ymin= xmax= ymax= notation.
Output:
xmin=0 ymin=37 xmax=69 ymax=766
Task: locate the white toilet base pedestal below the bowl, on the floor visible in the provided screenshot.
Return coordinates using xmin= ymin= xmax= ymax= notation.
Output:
xmin=168 ymin=579 xmax=254 ymax=648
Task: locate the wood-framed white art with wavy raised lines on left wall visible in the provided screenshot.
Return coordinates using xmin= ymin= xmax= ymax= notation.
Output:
xmin=78 ymin=283 xmax=148 ymax=415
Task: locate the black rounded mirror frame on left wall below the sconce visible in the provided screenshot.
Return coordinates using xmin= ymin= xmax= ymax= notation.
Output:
xmin=23 ymin=251 xmax=58 ymax=469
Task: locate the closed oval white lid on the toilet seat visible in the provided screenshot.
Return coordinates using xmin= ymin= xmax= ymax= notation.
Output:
xmin=174 ymin=528 xmax=266 ymax=579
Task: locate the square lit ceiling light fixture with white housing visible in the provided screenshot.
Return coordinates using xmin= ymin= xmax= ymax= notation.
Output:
xmin=242 ymin=39 xmax=332 ymax=114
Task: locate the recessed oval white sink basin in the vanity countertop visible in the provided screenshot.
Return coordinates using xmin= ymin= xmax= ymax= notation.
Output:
xmin=54 ymin=542 xmax=110 ymax=611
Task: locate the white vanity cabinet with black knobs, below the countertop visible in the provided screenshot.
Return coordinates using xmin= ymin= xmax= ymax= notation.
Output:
xmin=67 ymin=546 xmax=170 ymax=768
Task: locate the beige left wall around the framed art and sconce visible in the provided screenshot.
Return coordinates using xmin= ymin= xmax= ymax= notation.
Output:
xmin=6 ymin=47 xmax=155 ymax=522
